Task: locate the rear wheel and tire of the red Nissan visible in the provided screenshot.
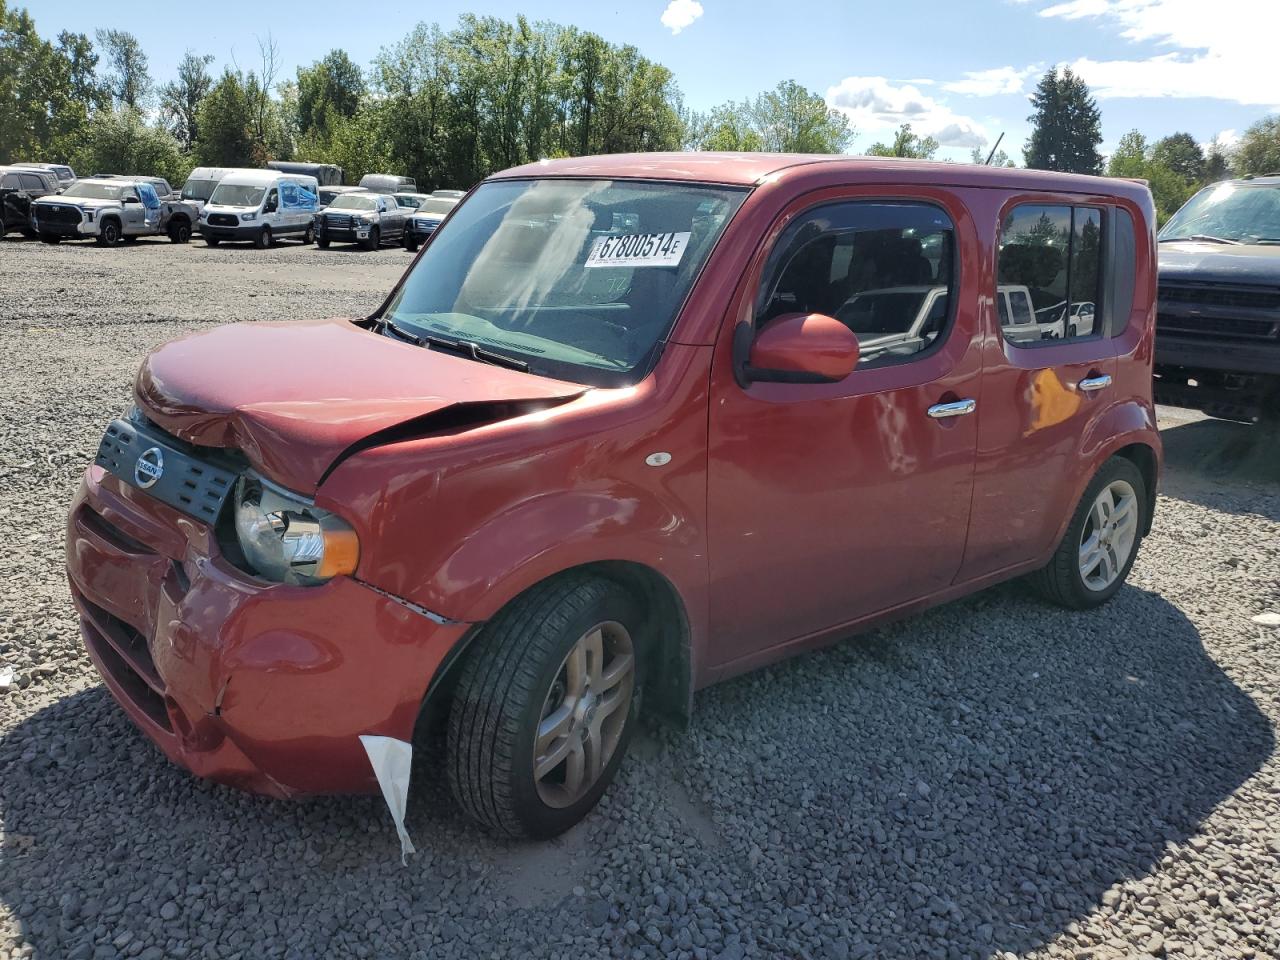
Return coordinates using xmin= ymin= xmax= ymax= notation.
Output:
xmin=1029 ymin=457 xmax=1148 ymax=611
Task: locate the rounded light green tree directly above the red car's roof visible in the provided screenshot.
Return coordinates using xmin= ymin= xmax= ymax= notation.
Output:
xmin=685 ymin=81 xmax=854 ymax=154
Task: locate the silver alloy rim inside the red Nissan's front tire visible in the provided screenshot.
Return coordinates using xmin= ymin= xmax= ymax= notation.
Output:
xmin=534 ymin=621 xmax=635 ymax=808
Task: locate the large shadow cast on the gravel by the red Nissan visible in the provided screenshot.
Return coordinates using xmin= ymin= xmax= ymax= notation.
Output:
xmin=0 ymin=586 xmax=1275 ymax=960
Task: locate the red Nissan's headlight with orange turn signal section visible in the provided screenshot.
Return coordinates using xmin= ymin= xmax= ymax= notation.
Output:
xmin=236 ymin=474 xmax=360 ymax=585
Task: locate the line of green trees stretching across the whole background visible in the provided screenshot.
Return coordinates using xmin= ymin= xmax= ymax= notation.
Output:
xmin=0 ymin=0 xmax=1280 ymax=212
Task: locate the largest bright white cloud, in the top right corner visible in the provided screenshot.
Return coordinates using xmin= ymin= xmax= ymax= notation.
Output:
xmin=1039 ymin=0 xmax=1277 ymax=106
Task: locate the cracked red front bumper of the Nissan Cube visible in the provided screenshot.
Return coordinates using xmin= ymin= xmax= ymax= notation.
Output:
xmin=67 ymin=466 xmax=470 ymax=796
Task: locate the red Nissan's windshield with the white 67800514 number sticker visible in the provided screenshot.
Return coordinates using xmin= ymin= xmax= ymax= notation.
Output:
xmin=387 ymin=179 xmax=746 ymax=387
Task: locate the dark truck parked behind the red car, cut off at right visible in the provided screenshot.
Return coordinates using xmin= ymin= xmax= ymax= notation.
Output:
xmin=1155 ymin=174 xmax=1280 ymax=421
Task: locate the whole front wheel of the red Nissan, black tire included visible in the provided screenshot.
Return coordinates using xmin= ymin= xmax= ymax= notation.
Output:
xmin=448 ymin=576 xmax=641 ymax=838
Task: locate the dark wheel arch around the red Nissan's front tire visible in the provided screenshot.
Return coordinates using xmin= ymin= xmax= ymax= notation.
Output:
xmin=417 ymin=561 xmax=694 ymax=731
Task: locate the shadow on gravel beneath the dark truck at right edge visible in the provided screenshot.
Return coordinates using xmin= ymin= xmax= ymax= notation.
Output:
xmin=1157 ymin=419 xmax=1280 ymax=521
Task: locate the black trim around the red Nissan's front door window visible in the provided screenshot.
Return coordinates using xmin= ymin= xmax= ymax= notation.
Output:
xmin=735 ymin=195 xmax=961 ymax=378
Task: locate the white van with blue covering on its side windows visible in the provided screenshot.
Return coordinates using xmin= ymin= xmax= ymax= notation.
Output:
xmin=200 ymin=170 xmax=319 ymax=250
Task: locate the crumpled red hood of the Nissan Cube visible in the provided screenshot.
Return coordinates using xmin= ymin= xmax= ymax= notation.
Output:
xmin=134 ymin=319 xmax=586 ymax=493
